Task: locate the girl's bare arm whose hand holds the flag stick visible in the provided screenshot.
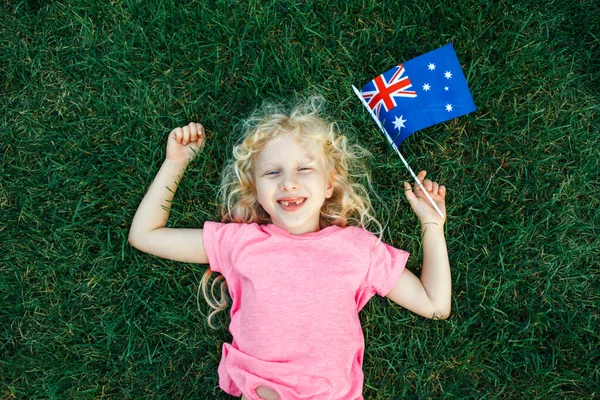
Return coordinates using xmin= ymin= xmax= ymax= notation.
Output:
xmin=386 ymin=171 xmax=452 ymax=319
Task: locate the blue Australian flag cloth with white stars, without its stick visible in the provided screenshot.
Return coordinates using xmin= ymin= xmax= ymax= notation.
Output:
xmin=360 ymin=43 xmax=476 ymax=145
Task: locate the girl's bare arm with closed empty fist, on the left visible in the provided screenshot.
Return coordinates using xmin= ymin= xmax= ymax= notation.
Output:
xmin=129 ymin=122 xmax=208 ymax=264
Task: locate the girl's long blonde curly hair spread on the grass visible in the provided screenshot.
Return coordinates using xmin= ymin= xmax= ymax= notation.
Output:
xmin=199 ymin=96 xmax=383 ymax=328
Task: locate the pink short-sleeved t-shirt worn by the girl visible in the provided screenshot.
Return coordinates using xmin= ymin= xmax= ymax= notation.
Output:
xmin=203 ymin=222 xmax=408 ymax=400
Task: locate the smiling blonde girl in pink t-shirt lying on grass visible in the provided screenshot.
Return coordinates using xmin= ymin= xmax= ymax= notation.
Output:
xmin=129 ymin=99 xmax=451 ymax=400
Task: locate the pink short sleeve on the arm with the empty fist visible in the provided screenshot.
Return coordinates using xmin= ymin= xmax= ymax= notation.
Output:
xmin=202 ymin=221 xmax=240 ymax=275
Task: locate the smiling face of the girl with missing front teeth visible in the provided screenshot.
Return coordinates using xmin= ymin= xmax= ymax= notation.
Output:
xmin=254 ymin=135 xmax=333 ymax=235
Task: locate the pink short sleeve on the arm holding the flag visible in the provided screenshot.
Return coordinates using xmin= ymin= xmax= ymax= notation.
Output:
xmin=364 ymin=241 xmax=409 ymax=296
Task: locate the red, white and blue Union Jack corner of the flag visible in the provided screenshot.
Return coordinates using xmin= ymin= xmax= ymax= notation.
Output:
xmin=361 ymin=64 xmax=417 ymax=115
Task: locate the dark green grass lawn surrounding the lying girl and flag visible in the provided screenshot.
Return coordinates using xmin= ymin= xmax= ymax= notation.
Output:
xmin=0 ymin=0 xmax=600 ymax=399
